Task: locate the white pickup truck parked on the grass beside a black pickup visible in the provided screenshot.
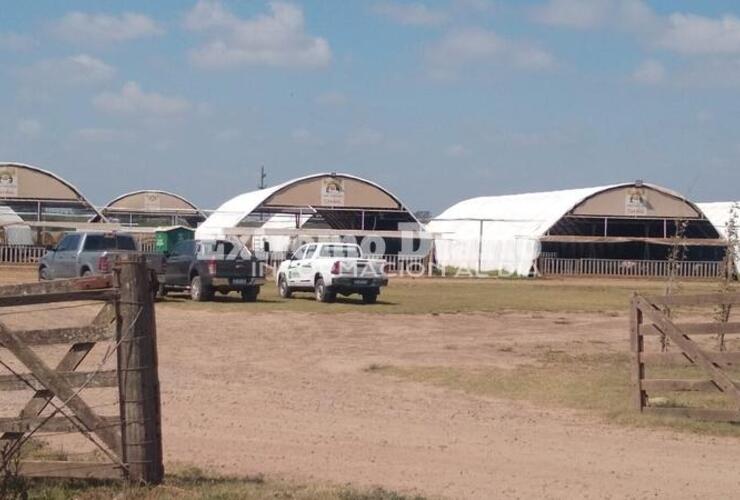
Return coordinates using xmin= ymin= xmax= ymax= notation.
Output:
xmin=276 ymin=243 xmax=388 ymax=304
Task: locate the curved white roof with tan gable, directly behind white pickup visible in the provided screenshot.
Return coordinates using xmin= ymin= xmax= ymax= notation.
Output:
xmin=196 ymin=173 xmax=418 ymax=237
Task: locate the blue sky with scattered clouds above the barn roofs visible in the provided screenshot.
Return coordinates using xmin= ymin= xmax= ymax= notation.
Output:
xmin=0 ymin=0 xmax=740 ymax=213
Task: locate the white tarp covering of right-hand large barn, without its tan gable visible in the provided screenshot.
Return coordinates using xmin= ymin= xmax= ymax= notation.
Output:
xmin=427 ymin=183 xmax=683 ymax=276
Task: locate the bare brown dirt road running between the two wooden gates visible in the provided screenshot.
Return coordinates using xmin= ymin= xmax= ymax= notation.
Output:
xmin=157 ymin=303 xmax=740 ymax=498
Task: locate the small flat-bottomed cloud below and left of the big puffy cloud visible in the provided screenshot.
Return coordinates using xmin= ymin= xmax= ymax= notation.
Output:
xmin=93 ymin=82 xmax=191 ymax=115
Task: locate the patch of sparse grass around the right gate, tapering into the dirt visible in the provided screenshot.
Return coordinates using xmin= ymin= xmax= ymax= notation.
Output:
xmin=368 ymin=351 xmax=740 ymax=437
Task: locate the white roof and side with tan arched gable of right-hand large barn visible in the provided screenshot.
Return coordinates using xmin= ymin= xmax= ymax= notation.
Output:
xmin=427 ymin=182 xmax=720 ymax=275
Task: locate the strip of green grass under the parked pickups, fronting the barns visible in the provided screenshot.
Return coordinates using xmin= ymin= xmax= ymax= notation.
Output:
xmin=159 ymin=278 xmax=714 ymax=314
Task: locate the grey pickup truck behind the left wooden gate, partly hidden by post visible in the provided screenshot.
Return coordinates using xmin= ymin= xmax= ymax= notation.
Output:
xmin=39 ymin=231 xmax=164 ymax=289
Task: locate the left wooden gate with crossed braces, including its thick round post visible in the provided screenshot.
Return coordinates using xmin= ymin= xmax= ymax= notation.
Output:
xmin=0 ymin=257 xmax=164 ymax=483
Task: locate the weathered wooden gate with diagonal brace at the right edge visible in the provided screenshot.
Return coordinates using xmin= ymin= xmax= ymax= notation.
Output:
xmin=630 ymin=293 xmax=740 ymax=422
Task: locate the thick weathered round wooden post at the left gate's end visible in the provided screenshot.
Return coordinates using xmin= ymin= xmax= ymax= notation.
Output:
xmin=116 ymin=255 xmax=164 ymax=484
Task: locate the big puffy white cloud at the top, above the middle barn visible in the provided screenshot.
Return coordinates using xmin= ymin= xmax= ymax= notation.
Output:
xmin=184 ymin=0 xmax=331 ymax=68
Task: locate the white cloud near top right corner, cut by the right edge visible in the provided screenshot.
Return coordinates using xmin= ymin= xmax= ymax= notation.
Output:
xmin=658 ymin=13 xmax=740 ymax=54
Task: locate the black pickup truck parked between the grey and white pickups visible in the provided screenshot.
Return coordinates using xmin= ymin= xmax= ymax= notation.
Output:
xmin=158 ymin=240 xmax=265 ymax=302
